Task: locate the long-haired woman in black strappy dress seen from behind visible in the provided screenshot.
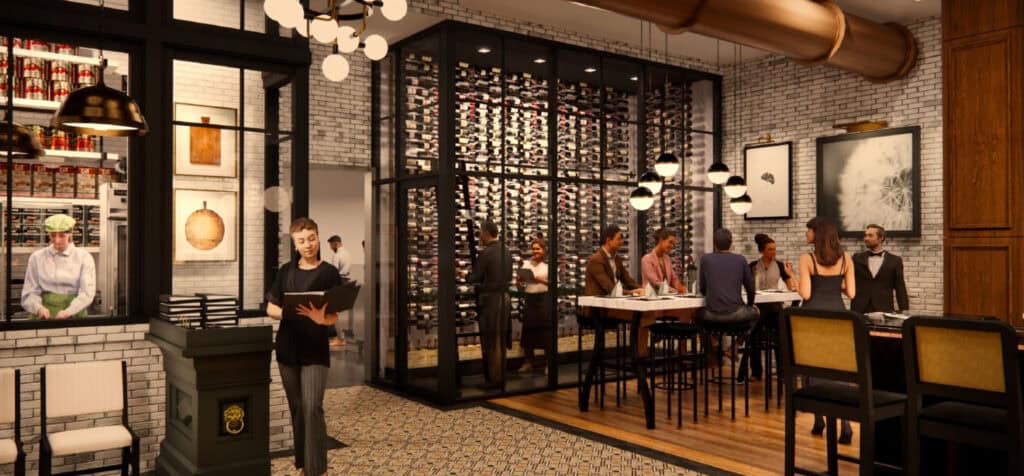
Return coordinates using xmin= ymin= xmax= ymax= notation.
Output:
xmin=799 ymin=217 xmax=857 ymax=444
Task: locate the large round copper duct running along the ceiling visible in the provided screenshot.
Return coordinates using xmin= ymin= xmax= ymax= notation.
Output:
xmin=575 ymin=0 xmax=918 ymax=82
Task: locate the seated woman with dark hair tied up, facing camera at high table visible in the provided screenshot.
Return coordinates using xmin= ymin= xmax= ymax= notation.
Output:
xmin=739 ymin=233 xmax=797 ymax=381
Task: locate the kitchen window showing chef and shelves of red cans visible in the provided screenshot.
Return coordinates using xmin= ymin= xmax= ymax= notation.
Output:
xmin=0 ymin=37 xmax=132 ymax=321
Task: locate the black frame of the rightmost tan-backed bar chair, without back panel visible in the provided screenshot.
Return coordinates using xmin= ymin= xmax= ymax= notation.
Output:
xmin=901 ymin=316 xmax=1024 ymax=475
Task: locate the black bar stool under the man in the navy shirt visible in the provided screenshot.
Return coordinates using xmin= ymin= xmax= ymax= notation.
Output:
xmin=697 ymin=315 xmax=752 ymax=420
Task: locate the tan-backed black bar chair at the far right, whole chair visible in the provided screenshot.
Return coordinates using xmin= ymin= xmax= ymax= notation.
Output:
xmin=902 ymin=317 xmax=1024 ymax=475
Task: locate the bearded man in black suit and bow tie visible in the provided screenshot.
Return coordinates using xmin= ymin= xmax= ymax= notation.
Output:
xmin=850 ymin=224 xmax=910 ymax=314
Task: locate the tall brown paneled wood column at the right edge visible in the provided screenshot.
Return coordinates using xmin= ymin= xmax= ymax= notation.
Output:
xmin=942 ymin=0 xmax=1024 ymax=326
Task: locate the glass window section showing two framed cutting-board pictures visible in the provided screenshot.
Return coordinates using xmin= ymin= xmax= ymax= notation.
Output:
xmin=171 ymin=59 xmax=291 ymax=310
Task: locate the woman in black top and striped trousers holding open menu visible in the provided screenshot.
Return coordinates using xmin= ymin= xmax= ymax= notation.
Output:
xmin=266 ymin=218 xmax=341 ymax=475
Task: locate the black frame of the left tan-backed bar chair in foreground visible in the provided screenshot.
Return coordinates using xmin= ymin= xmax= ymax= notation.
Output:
xmin=779 ymin=307 xmax=906 ymax=475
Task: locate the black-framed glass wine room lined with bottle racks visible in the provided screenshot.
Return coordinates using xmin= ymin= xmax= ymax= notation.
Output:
xmin=370 ymin=21 xmax=722 ymax=402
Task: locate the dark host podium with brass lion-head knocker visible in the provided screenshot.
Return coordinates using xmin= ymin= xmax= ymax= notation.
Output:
xmin=145 ymin=318 xmax=273 ymax=476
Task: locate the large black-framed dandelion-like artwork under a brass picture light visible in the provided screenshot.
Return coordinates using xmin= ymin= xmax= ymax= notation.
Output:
xmin=817 ymin=126 xmax=921 ymax=236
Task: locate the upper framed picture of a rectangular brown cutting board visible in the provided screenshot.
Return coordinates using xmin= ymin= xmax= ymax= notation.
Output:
xmin=174 ymin=102 xmax=239 ymax=178
